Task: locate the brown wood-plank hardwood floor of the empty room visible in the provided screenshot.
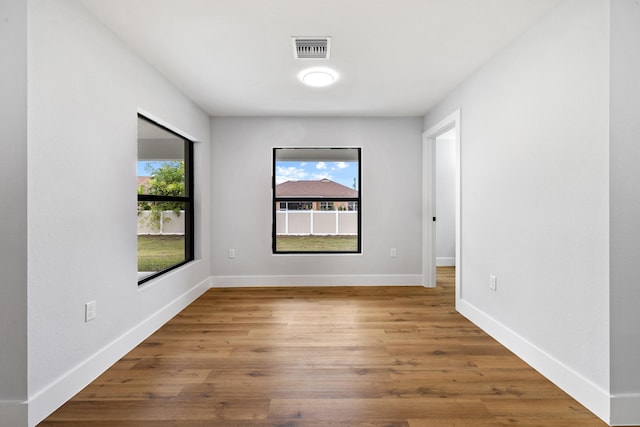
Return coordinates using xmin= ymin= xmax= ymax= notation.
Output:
xmin=40 ymin=267 xmax=606 ymax=427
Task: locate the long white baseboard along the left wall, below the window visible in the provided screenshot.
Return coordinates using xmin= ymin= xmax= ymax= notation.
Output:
xmin=28 ymin=279 xmax=210 ymax=426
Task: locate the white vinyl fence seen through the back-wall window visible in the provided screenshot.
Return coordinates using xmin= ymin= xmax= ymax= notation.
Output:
xmin=276 ymin=210 xmax=358 ymax=236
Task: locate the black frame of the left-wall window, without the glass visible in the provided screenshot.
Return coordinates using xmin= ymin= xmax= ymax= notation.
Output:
xmin=136 ymin=113 xmax=195 ymax=286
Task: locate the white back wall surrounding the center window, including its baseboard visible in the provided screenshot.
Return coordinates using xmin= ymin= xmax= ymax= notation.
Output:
xmin=211 ymin=118 xmax=422 ymax=285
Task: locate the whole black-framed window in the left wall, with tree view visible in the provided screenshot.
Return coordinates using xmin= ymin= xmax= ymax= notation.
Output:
xmin=137 ymin=115 xmax=194 ymax=284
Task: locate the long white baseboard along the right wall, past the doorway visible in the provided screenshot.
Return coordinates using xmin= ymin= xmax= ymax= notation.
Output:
xmin=456 ymin=300 xmax=612 ymax=422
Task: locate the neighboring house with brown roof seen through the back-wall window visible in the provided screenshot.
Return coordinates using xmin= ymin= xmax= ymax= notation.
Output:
xmin=276 ymin=178 xmax=358 ymax=211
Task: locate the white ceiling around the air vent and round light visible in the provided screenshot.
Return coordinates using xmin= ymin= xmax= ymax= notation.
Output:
xmin=81 ymin=0 xmax=559 ymax=116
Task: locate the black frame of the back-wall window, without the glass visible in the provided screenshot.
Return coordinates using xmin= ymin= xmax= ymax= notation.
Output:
xmin=271 ymin=146 xmax=362 ymax=255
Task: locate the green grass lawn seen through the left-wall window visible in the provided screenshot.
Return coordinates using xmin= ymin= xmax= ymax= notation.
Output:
xmin=138 ymin=236 xmax=184 ymax=271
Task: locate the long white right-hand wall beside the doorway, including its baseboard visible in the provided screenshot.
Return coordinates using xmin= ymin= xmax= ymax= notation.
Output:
xmin=424 ymin=0 xmax=608 ymax=419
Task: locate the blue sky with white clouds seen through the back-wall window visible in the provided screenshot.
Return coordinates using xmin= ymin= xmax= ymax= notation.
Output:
xmin=276 ymin=161 xmax=360 ymax=189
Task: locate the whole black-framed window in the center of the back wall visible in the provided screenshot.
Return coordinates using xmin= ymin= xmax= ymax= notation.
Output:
xmin=272 ymin=147 xmax=362 ymax=254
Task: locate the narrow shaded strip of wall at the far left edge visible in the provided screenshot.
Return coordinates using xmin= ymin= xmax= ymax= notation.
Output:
xmin=0 ymin=0 xmax=27 ymax=424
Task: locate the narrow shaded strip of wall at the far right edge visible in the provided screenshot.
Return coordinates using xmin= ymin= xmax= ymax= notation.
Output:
xmin=610 ymin=0 xmax=640 ymax=424
